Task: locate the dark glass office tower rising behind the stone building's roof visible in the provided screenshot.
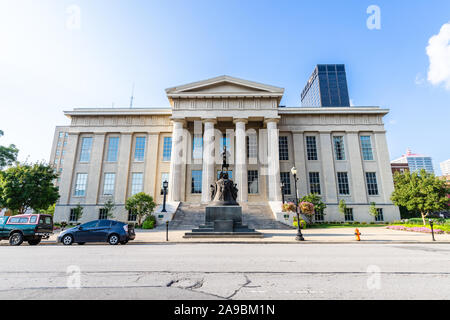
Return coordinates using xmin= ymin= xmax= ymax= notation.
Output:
xmin=302 ymin=64 xmax=350 ymax=107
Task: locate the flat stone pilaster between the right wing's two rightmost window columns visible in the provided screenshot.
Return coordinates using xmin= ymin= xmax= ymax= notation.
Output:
xmin=347 ymin=131 xmax=367 ymax=203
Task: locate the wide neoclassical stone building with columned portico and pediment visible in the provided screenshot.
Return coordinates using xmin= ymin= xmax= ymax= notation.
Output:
xmin=51 ymin=76 xmax=399 ymax=222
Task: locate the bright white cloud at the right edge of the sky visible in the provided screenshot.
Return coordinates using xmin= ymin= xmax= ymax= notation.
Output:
xmin=426 ymin=22 xmax=450 ymax=90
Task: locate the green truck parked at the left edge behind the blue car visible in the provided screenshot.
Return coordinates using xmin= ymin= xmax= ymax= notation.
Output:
xmin=0 ymin=214 xmax=53 ymax=246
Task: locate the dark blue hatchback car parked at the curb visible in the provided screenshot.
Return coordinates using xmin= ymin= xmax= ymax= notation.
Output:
xmin=58 ymin=220 xmax=136 ymax=246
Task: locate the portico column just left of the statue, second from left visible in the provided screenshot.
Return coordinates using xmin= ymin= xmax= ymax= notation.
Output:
xmin=202 ymin=119 xmax=217 ymax=203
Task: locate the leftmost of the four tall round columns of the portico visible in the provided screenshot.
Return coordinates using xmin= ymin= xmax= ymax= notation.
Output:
xmin=168 ymin=119 xmax=185 ymax=201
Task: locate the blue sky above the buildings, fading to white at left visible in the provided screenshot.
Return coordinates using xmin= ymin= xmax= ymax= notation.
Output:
xmin=0 ymin=0 xmax=450 ymax=173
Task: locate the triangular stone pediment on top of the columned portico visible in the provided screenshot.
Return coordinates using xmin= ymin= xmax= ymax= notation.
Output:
xmin=166 ymin=76 xmax=284 ymax=96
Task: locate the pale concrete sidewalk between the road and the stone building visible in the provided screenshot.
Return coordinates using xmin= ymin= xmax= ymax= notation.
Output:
xmin=24 ymin=227 xmax=450 ymax=245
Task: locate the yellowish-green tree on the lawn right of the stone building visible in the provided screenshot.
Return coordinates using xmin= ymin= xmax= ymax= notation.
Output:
xmin=391 ymin=169 xmax=449 ymax=225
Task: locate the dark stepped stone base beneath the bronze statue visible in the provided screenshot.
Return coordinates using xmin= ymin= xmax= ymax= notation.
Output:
xmin=184 ymin=205 xmax=264 ymax=238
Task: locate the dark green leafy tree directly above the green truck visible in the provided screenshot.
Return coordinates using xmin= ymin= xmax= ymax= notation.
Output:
xmin=0 ymin=163 xmax=59 ymax=214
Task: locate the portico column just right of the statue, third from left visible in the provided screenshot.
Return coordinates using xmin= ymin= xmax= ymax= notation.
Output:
xmin=234 ymin=119 xmax=248 ymax=202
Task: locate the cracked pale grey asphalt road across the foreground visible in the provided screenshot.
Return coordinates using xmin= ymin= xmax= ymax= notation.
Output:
xmin=0 ymin=243 xmax=450 ymax=299
